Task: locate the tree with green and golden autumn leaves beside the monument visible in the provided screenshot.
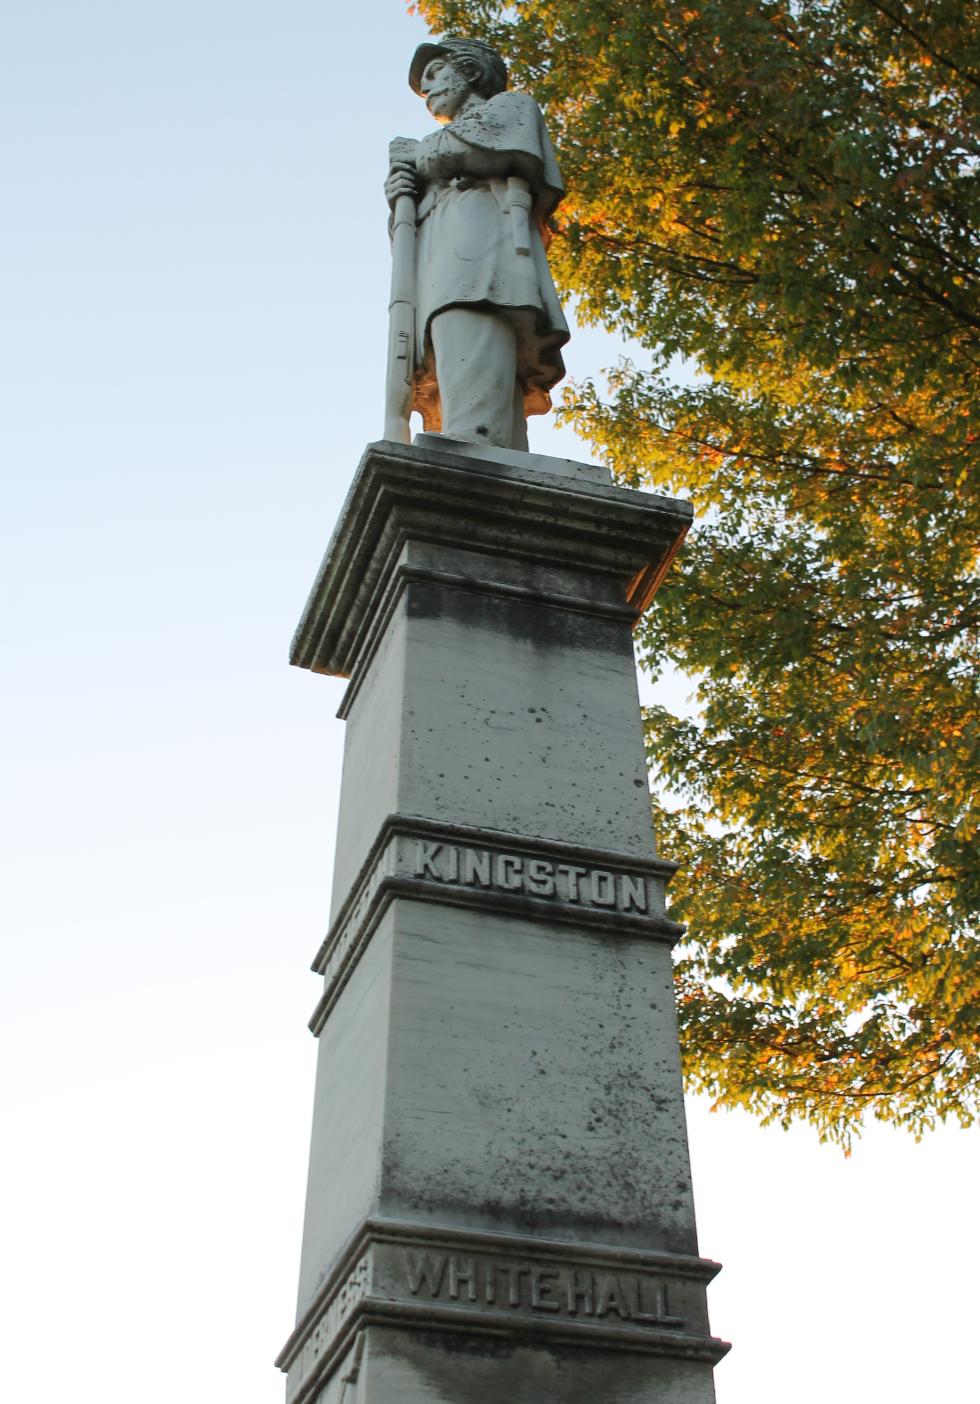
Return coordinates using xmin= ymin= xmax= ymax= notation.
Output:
xmin=417 ymin=0 xmax=980 ymax=1143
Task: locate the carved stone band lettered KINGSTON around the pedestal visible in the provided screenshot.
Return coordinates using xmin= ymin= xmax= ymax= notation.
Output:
xmin=309 ymin=814 xmax=684 ymax=1035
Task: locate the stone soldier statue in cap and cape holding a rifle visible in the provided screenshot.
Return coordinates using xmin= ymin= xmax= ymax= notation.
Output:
xmin=385 ymin=38 xmax=569 ymax=449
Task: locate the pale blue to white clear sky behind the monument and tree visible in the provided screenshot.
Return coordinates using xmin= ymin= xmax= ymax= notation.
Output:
xmin=0 ymin=0 xmax=980 ymax=1404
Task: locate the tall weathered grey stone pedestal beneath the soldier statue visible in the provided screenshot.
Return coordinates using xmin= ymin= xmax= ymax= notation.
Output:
xmin=278 ymin=435 xmax=726 ymax=1404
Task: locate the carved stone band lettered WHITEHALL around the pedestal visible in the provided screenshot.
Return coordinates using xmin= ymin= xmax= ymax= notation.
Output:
xmin=275 ymin=1217 xmax=729 ymax=1404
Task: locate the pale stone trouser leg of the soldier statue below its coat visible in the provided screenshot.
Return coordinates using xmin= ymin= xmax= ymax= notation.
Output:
xmin=430 ymin=307 xmax=528 ymax=449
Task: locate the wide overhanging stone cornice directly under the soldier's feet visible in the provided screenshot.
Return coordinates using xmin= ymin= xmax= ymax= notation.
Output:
xmin=291 ymin=441 xmax=692 ymax=677
